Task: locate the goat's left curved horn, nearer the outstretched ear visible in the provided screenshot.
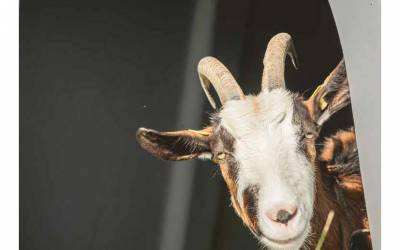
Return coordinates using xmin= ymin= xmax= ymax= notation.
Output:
xmin=197 ymin=57 xmax=244 ymax=109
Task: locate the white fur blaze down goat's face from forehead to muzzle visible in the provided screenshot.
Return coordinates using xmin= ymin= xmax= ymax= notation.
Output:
xmin=219 ymin=89 xmax=314 ymax=249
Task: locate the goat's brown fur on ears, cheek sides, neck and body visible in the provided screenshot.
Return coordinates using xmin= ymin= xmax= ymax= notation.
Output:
xmin=137 ymin=60 xmax=371 ymax=250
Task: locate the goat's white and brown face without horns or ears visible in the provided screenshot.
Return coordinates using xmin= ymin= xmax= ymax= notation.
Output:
xmin=211 ymin=89 xmax=314 ymax=248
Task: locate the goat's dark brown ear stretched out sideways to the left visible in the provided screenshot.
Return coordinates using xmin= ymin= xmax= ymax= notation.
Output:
xmin=136 ymin=127 xmax=212 ymax=161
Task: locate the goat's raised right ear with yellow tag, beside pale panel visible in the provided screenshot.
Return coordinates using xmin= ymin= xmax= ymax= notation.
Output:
xmin=305 ymin=59 xmax=350 ymax=126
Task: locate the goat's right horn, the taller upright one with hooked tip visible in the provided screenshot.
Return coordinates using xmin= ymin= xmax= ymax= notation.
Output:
xmin=261 ymin=33 xmax=298 ymax=90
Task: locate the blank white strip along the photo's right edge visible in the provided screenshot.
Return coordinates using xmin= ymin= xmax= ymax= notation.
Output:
xmin=382 ymin=0 xmax=400 ymax=249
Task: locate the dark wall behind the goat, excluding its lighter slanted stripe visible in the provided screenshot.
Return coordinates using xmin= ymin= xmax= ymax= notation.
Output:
xmin=20 ymin=0 xmax=352 ymax=250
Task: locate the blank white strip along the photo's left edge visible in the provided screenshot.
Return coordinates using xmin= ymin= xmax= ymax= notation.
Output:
xmin=0 ymin=0 xmax=19 ymax=250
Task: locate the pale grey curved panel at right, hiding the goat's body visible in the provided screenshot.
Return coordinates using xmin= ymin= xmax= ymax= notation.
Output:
xmin=329 ymin=0 xmax=381 ymax=250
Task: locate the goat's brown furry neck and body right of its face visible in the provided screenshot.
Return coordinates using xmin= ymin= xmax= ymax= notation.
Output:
xmin=312 ymin=129 xmax=371 ymax=249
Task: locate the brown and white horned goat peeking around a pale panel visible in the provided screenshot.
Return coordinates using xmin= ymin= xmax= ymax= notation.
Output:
xmin=136 ymin=33 xmax=364 ymax=249
